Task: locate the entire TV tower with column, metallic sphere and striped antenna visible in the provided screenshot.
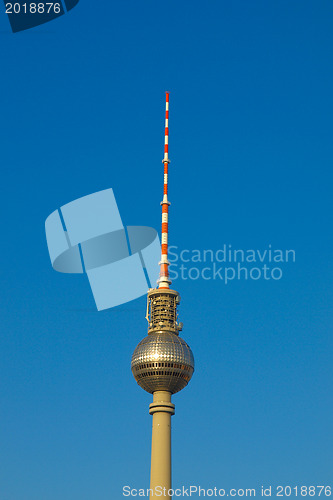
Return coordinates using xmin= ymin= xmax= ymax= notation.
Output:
xmin=132 ymin=92 xmax=194 ymax=499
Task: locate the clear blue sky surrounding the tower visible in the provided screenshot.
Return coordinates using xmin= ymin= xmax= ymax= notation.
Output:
xmin=0 ymin=0 xmax=333 ymax=500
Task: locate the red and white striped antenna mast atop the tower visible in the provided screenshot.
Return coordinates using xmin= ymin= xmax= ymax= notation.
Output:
xmin=158 ymin=92 xmax=171 ymax=288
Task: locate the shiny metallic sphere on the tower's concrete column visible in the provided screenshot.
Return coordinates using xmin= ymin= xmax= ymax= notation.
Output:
xmin=132 ymin=332 xmax=194 ymax=394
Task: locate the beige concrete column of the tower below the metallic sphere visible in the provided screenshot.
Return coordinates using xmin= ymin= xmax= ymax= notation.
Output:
xmin=149 ymin=391 xmax=175 ymax=500
